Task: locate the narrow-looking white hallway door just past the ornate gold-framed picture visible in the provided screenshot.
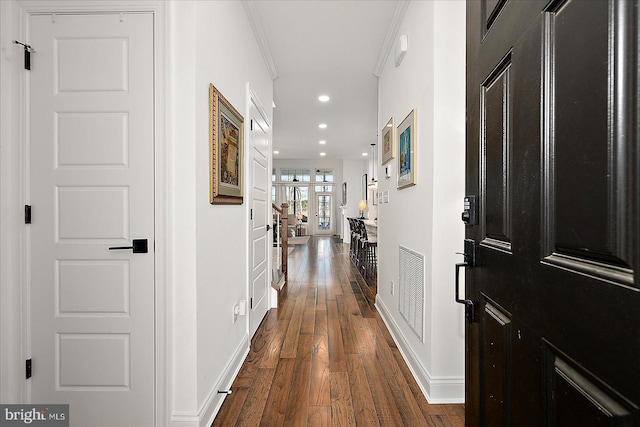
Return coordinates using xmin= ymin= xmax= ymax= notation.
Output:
xmin=249 ymin=98 xmax=272 ymax=337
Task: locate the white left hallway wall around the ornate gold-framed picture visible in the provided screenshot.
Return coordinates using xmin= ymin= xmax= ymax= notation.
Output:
xmin=170 ymin=0 xmax=273 ymax=425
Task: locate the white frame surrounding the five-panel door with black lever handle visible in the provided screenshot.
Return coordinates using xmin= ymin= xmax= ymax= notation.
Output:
xmin=0 ymin=0 xmax=172 ymax=425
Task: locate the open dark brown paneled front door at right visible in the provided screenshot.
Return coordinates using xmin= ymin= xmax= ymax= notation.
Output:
xmin=466 ymin=0 xmax=640 ymax=427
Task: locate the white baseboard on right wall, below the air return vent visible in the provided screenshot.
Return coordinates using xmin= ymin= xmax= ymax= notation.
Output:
xmin=376 ymin=296 xmax=464 ymax=404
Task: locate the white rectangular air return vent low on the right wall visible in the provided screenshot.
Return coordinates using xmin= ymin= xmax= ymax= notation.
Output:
xmin=398 ymin=246 xmax=424 ymax=340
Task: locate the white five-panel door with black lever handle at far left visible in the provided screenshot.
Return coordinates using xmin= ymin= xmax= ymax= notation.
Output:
xmin=26 ymin=13 xmax=154 ymax=427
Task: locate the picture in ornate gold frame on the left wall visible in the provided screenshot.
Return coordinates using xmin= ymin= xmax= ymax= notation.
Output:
xmin=209 ymin=83 xmax=244 ymax=205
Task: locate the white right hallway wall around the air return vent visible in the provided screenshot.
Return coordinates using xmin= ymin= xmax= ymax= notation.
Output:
xmin=377 ymin=0 xmax=465 ymax=403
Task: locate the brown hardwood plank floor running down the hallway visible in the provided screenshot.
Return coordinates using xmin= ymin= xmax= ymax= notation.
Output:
xmin=213 ymin=237 xmax=464 ymax=427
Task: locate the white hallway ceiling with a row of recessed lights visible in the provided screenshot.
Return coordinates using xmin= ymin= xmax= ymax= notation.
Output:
xmin=244 ymin=0 xmax=406 ymax=159
